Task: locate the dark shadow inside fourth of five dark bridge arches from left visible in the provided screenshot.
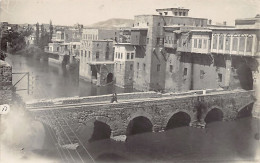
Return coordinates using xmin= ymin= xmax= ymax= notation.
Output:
xmin=204 ymin=107 xmax=224 ymax=123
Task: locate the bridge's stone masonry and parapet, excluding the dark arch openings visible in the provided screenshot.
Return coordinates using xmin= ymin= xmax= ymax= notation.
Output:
xmin=27 ymin=90 xmax=255 ymax=144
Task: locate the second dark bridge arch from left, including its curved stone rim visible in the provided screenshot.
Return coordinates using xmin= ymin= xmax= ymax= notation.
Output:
xmin=126 ymin=112 xmax=154 ymax=136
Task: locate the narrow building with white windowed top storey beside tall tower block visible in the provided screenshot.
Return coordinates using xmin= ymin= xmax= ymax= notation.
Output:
xmin=114 ymin=43 xmax=135 ymax=89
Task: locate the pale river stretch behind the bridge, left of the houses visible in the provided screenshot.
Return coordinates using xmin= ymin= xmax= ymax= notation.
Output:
xmin=6 ymin=55 xmax=136 ymax=100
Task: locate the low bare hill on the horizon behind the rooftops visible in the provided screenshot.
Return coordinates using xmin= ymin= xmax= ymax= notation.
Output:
xmin=88 ymin=18 xmax=134 ymax=28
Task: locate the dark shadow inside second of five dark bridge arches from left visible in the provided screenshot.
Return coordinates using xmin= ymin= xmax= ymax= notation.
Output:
xmin=126 ymin=116 xmax=153 ymax=136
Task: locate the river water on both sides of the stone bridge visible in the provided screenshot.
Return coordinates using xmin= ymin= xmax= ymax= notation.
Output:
xmin=2 ymin=56 xmax=260 ymax=162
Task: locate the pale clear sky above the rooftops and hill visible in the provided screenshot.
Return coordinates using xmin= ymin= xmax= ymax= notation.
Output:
xmin=0 ymin=0 xmax=260 ymax=25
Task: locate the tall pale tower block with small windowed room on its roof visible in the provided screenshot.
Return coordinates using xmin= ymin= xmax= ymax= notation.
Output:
xmin=131 ymin=8 xmax=207 ymax=90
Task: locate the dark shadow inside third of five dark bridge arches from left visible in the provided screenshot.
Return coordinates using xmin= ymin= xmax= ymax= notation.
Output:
xmin=165 ymin=111 xmax=191 ymax=130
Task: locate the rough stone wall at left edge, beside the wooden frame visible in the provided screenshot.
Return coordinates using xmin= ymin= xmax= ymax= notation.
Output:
xmin=0 ymin=60 xmax=12 ymax=105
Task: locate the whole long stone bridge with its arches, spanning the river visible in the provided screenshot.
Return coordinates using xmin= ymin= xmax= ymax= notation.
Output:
xmin=26 ymin=90 xmax=255 ymax=144
